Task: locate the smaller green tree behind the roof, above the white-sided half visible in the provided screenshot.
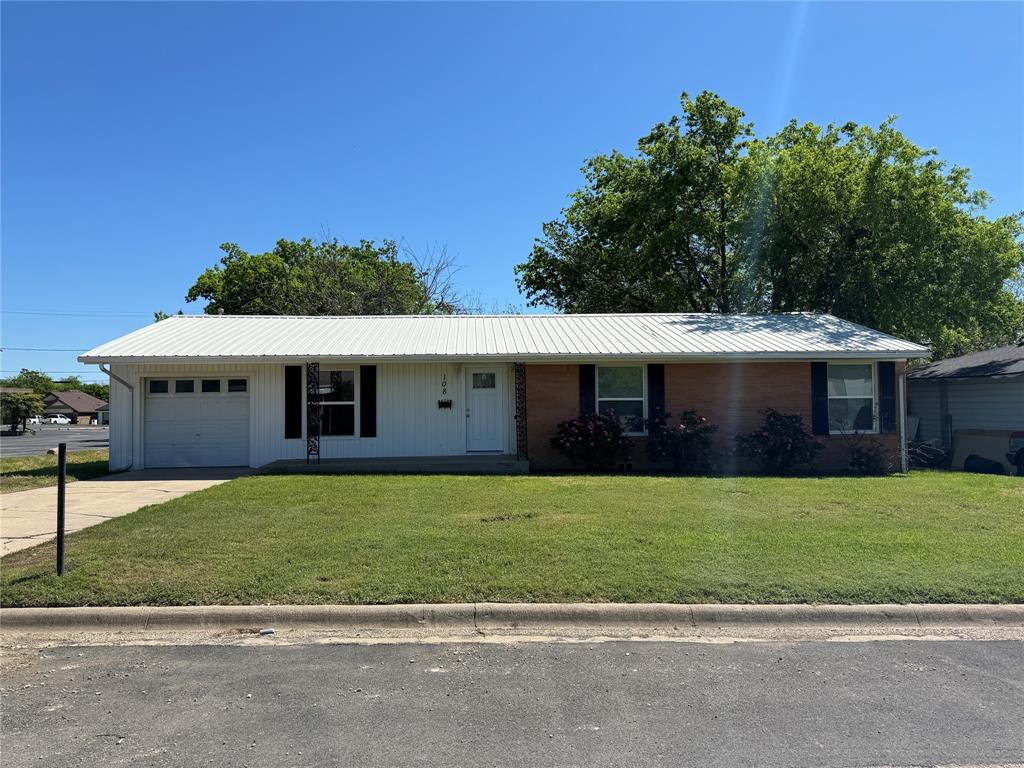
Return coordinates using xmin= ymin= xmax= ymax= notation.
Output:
xmin=184 ymin=238 xmax=457 ymax=321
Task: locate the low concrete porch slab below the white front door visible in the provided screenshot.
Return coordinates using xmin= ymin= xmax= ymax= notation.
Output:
xmin=260 ymin=454 xmax=529 ymax=475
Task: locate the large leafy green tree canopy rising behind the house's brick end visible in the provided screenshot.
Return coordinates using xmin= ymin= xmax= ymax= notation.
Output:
xmin=516 ymin=92 xmax=1024 ymax=356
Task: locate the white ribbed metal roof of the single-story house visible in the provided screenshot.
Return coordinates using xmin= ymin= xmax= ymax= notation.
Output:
xmin=79 ymin=313 xmax=928 ymax=362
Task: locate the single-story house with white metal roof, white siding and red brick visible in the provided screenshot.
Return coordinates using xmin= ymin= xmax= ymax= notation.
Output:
xmin=79 ymin=313 xmax=928 ymax=470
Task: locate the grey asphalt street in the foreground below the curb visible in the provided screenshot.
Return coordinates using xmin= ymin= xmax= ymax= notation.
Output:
xmin=0 ymin=640 xmax=1024 ymax=768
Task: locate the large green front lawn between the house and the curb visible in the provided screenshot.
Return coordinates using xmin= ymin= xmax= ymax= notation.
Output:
xmin=0 ymin=472 xmax=1024 ymax=606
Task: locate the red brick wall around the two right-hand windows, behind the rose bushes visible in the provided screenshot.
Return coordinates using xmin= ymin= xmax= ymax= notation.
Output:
xmin=526 ymin=362 xmax=903 ymax=472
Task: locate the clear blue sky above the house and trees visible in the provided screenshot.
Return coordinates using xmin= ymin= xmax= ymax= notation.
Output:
xmin=0 ymin=2 xmax=1024 ymax=379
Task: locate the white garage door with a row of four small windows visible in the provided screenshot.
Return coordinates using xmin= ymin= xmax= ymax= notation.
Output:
xmin=143 ymin=376 xmax=249 ymax=467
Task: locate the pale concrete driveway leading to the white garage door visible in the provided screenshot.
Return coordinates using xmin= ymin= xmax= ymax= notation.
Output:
xmin=0 ymin=467 xmax=252 ymax=555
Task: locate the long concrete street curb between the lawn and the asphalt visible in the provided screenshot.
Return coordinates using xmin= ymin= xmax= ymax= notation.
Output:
xmin=0 ymin=603 xmax=1024 ymax=632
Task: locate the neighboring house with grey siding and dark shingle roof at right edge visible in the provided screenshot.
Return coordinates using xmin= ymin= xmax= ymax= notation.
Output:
xmin=907 ymin=344 xmax=1024 ymax=471
